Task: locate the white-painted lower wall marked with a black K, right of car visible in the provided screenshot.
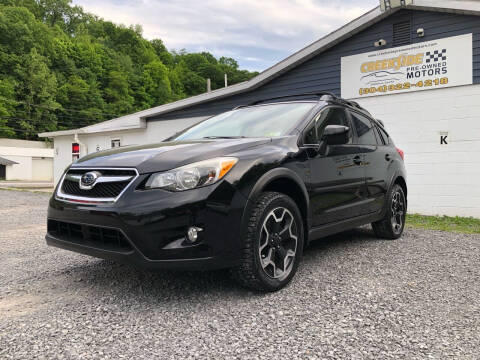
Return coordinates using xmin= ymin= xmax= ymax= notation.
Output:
xmin=360 ymin=85 xmax=480 ymax=218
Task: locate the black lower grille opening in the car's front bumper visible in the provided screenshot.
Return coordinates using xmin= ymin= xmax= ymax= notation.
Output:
xmin=48 ymin=219 xmax=133 ymax=252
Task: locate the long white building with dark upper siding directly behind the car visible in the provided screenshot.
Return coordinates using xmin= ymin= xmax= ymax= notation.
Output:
xmin=40 ymin=0 xmax=480 ymax=218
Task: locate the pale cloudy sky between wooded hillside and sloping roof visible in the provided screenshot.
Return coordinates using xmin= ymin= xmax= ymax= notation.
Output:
xmin=73 ymin=0 xmax=379 ymax=71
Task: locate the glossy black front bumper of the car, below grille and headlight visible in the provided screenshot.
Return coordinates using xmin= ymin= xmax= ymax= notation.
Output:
xmin=46 ymin=176 xmax=247 ymax=270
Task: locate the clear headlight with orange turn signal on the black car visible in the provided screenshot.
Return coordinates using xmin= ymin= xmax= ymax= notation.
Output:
xmin=145 ymin=157 xmax=238 ymax=191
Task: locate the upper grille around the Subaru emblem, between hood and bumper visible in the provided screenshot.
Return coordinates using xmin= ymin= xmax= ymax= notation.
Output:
xmin=60 ymin=169 xmax=137 ymax=198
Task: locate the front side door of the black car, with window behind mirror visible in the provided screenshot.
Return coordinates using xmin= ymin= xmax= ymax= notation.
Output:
xmin=304 ymin=107 xmax=365 ymax=226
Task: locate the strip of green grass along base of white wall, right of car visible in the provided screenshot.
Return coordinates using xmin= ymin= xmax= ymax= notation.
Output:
xmin=406 ymin=214 xmax=480 ymax=234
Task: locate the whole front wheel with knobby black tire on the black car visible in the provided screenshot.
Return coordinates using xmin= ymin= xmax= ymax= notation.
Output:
xmin=232 ymin=192 xmax=304 ymax=291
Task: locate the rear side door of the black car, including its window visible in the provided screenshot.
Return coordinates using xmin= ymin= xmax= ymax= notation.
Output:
xmin=349 ymin=110 xmax=393 ymax=213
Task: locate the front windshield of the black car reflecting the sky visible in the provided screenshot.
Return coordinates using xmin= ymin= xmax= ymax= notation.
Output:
xmin=173 ymin=102 xmax=315 ymax=140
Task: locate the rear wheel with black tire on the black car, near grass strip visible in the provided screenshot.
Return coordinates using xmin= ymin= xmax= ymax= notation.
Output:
xmin=372 ymin=184 xmax=407 ymax=240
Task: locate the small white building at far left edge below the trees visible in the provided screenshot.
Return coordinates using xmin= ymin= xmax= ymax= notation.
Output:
xmin=0 ymin=139 xmax=53 ymax=181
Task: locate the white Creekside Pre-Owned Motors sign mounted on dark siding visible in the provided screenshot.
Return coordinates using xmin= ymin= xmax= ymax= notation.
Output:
xmin=341 ymin=34 xmax=473 ymax=99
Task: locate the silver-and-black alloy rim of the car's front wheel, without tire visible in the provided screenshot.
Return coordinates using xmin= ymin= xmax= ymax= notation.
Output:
xmin=258 ymin=207 xmax=298 ymax=281
